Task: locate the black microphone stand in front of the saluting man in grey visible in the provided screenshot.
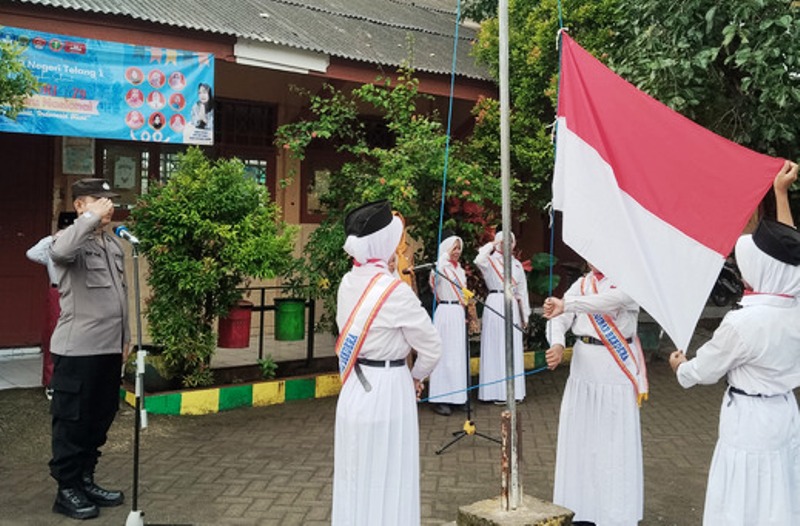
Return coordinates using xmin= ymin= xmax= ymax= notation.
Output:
xmin=125 ymin=243 xmax=147 ymax=526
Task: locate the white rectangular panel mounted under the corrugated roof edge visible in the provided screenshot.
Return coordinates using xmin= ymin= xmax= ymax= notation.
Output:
xmin=233 ymin=38 xmax=330 ymax=75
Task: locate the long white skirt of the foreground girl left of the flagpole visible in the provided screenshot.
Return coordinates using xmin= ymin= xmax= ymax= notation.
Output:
xmin=332 ymin=366 xmax=420 ymax=526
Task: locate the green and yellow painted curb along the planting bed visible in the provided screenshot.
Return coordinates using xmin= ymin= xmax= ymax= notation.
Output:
xmin=120 ymin=351 xmax=545 ymax=415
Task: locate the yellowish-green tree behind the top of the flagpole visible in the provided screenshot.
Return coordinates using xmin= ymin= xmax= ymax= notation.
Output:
xmin=472 ymin=0 xmax=617 ymax=207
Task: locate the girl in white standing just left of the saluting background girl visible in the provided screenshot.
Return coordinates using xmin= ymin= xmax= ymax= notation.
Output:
xmin=428 ymin=233 xmax=468 ymax=416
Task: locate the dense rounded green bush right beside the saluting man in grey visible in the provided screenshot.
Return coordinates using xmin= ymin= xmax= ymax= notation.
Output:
xmin=131 ymin=147 xmax=296 ymax=387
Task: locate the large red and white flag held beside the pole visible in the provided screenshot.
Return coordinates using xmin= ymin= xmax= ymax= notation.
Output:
xmin=553 ymin=33 xmax=783 ymax=350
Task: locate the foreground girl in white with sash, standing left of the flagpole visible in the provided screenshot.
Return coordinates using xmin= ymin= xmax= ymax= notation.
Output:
xmin=332 ymin=201 xmax=442 ymax=526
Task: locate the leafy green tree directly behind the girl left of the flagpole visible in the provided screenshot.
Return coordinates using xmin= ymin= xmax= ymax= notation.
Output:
xmin=276 ymin=69 xmax=526 ymax=330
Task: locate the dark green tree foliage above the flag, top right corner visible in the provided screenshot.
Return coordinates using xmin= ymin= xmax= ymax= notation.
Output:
xmin=609 ymin=0 xmax=800 ymax=159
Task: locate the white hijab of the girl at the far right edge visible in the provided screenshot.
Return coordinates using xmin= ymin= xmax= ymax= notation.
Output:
xmin=736 ymin=235 xmax=800 ymax=296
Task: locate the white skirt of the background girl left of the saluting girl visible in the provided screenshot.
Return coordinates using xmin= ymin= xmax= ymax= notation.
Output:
xmin=428 ymin=303 xmax=467 ymax=404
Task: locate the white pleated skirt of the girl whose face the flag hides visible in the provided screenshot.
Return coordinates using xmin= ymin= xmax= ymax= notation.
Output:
xmin=553 ymin=341 xmax=644 ymax=526
